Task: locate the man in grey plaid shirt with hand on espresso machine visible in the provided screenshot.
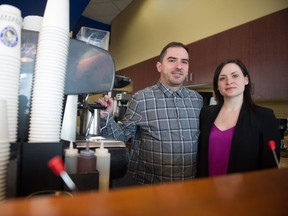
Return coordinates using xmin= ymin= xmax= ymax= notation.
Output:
xmin=98 ymin=42 xmax=203 ymax=184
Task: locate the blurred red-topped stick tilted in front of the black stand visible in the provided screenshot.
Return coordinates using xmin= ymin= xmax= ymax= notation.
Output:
xmin=48 ymin=156 xmax=77 ymax=191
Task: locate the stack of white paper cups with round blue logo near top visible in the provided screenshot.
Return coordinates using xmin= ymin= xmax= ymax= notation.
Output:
xmin=0 ymin=4 xmax=22 ymax=142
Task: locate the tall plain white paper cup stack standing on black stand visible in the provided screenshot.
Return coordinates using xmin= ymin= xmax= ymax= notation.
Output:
xmin=28 ymin=0 xmax=69 ymax=142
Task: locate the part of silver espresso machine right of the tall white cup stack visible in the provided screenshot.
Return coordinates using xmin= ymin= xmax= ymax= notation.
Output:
xmin=62 ymin=34 xmax=128 ymax=186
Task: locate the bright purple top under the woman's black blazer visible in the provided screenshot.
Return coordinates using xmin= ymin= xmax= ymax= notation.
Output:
xmin=208 ymin=124 xmax=235 ymax=176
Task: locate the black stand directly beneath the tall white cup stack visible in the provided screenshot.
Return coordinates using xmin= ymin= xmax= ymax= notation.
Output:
xmin=17 ymin=142 xmax=63 ymax=196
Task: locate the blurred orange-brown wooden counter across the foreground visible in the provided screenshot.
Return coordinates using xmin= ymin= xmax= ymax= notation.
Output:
xmin=0 ymin=168 xmax=288 ymax=216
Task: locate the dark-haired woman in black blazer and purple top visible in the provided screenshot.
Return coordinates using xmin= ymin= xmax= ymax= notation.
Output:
xmin=197 ymin=59 xmax=280 ymax=177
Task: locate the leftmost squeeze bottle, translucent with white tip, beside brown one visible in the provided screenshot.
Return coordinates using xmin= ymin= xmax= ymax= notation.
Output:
xmin=64 ymin=141 xmax=79 ymax=174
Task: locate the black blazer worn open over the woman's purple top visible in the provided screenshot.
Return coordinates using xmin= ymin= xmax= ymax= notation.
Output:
xmin=197 ymin=103 xmax=280 ymax=177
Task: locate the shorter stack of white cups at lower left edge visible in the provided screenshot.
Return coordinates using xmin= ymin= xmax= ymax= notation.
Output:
xmin=0 ymin=98 xmax=10 ymax=201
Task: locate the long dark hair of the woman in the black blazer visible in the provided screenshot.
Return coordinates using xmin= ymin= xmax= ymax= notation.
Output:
xmin=213 ymin=59 xmax=256 ymax=108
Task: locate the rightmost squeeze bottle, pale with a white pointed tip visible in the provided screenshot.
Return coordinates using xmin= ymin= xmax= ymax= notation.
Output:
xmin=95 ymin=142 xmax=111 ymax=191
